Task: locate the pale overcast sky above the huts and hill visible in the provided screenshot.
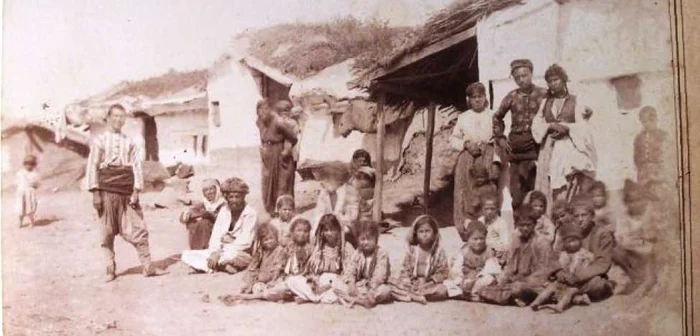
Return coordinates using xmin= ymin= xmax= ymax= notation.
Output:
xmin=2 ymin=0 xmax=451 ymax=121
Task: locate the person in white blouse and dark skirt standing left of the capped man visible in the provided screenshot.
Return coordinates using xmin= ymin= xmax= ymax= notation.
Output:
xmin=450 ymin=83 xmax=500 ymax=225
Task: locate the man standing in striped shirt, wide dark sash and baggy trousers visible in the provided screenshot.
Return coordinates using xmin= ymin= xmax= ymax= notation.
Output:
xmin=86 ymin=104 xmax=163 ymax=282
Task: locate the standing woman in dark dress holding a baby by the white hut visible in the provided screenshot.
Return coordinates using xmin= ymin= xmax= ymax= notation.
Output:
xmin=256 ymin=100 xmax=297 ymax=213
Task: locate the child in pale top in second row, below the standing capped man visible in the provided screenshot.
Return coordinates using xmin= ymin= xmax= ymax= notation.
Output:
xmin=478 ymin=193 xmax=515 ymax=262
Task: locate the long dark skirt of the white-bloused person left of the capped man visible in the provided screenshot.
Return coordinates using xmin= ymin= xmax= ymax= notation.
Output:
xmin=453 ymin=144 xmax=494 ymax=225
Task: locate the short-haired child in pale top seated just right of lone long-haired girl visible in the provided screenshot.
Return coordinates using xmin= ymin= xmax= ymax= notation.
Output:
xmin=445 ymin=221 xmax=501 ymax=301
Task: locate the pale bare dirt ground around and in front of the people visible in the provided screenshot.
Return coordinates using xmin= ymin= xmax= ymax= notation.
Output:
xmin=2 ymin=150 xmax=681 ymax=335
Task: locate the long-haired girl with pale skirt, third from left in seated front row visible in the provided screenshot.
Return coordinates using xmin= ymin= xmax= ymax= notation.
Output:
xmin=287 ymin=214 xmax=354 ymax=303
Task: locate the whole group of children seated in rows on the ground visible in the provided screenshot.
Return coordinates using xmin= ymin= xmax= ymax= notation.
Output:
xmin=205 ymin=171 xmax=652 ymax=312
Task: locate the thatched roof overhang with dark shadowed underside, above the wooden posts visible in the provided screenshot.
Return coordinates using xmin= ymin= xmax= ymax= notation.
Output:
xmin=353 ymin=0 xmax=523 ymax=108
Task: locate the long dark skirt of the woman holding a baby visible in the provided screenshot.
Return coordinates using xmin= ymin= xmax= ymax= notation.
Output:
xmin=260 ymin=142 xmax=296 ymax=213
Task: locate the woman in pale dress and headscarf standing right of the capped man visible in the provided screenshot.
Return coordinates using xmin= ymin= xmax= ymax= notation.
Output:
xmin=532 ymin=64 xmax=598 ymax=209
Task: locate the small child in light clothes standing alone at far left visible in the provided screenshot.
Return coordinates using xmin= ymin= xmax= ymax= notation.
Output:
xmin=16 ymin=154 xmax=39 ymax=228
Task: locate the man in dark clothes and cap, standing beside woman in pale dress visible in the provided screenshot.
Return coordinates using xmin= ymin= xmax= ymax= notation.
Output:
xmin=493 ymin=59 xmax=547 ymax=210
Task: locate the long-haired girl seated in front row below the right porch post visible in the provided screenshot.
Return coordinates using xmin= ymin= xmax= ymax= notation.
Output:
xmin=391 ymin=215 xmax=449 ymax=304
